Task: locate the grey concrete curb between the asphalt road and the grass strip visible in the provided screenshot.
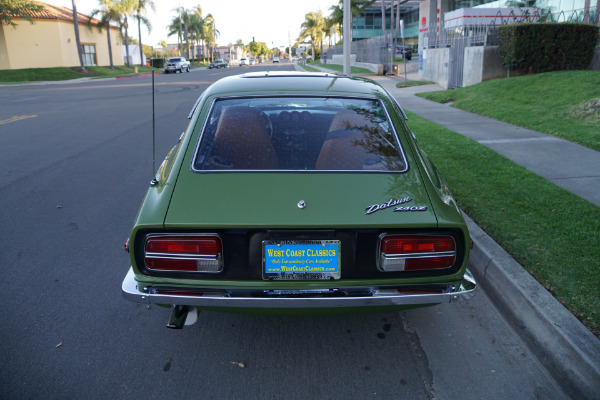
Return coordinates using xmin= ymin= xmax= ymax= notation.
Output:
xmin=465 ymin=215 xmax=600 ymax=399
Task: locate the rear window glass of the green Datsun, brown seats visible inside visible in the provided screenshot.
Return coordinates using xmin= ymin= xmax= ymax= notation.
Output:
xmin=193 ymin=97 xmax=407 ymax=172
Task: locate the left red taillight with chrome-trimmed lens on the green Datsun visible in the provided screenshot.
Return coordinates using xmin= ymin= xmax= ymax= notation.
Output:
xmin=144 ymin=235 xmax=223 ymax=272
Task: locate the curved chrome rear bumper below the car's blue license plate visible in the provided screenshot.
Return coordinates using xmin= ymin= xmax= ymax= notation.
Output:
xmin=122 ymin=268 xmax=477 ymax=308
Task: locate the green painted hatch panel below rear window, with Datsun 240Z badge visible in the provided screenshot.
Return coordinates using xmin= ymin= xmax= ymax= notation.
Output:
xmin=165 ymin=169 xmax=437 ymax=229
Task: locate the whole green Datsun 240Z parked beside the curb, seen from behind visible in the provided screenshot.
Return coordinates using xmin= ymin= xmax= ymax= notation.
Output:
xmin=122 ymin=72 xmax=475 ymax=328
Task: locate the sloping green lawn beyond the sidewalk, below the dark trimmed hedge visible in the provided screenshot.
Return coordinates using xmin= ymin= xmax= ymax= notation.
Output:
xmin=419 ymin=71 xmax=600 ymax=151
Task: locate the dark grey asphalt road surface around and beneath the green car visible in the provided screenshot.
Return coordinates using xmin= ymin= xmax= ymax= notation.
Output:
xmin=0 ymin=64 xmax=566 ymax=400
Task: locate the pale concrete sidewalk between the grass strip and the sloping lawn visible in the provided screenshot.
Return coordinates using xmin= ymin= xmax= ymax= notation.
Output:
xmin=371 ymin=76 xmax=600 ymax=206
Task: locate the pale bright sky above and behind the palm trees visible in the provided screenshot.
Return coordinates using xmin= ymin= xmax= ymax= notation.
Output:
xmin=43 ymin=0 xmax=338 ymax=48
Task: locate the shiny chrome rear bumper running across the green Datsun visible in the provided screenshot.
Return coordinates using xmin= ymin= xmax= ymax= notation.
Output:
xmin=122 ymin=268 xmax=477 ymax=309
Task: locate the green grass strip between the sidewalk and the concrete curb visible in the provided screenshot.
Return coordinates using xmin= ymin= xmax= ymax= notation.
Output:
xmin=407 ymin=113 xmax=600 ymax=337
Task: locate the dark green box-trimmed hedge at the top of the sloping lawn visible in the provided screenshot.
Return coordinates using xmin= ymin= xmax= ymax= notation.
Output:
xmin=498 ymin=23 xmax=598 ymax=73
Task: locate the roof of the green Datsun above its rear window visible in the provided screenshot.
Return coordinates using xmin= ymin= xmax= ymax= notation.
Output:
xmin=205 ymin=71 xmax=388 ymax=98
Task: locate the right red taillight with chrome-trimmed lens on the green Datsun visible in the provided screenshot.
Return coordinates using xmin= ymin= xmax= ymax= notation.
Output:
xmin=378 ymin=235 xmax=456 ymax=271
